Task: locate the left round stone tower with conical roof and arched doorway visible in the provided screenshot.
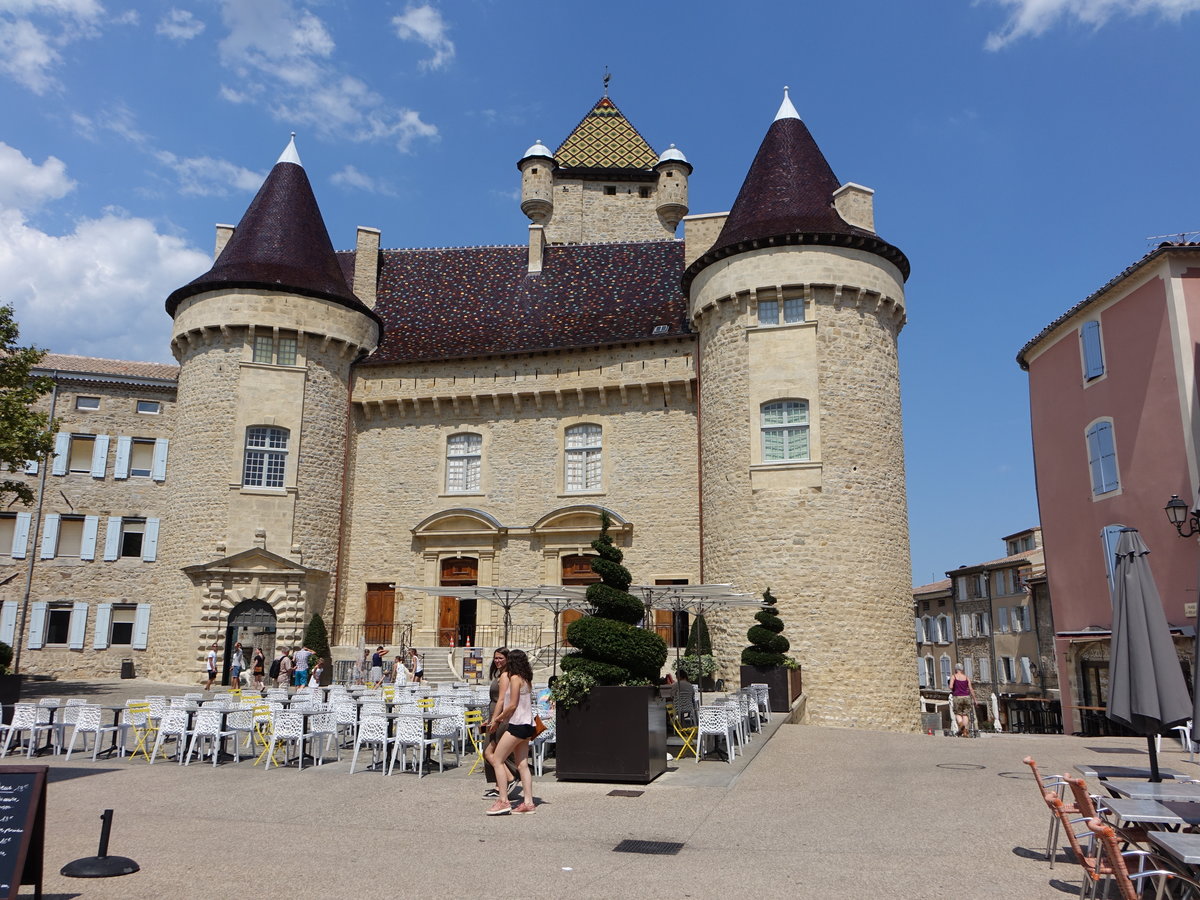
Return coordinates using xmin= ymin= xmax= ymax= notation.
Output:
xmin=160 ymin=142 xmax=380 ymax=672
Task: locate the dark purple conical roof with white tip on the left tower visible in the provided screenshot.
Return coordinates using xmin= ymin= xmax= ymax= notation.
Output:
xmin=167 ymin=139 xmax=376 ymax=318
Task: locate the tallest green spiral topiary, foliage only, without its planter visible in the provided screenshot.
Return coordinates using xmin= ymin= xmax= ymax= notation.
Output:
xmin=562 ymin=512 xmax=667 ymax=684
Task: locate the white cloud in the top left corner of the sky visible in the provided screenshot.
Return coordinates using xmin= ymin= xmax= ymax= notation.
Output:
xmin=0 ymin=0 xmax=104 ymax=95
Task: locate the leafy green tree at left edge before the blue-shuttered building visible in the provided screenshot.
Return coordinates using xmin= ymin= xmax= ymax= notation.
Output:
xmin=0 ymin=306 xmax=58 ymax=506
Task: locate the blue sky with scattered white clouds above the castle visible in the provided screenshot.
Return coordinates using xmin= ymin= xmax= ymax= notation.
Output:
xmin=0 ymin=0 xmax=1200 ymax=583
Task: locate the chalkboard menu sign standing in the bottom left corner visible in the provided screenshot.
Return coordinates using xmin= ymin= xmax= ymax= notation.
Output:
xmin=0 ymin=766 xmax=48 ymax=900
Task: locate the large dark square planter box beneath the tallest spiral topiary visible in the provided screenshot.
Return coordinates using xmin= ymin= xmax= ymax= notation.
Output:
xmin=554 ymin=688 xmax=667 ymax=785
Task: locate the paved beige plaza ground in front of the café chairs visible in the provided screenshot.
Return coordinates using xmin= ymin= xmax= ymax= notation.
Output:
xmin=8 ymin=680 xmax=1180 ymax=900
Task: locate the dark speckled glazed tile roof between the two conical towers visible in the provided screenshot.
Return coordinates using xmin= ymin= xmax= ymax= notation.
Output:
xmin=355 ymin=241 xmax=689 ymax=365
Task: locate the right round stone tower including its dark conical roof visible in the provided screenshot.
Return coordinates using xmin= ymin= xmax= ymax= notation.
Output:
xmin=684 ymin=89 xmax=917 ymax=731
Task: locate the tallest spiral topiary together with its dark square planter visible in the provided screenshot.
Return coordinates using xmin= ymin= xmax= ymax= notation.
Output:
xmin=553 ymin=512 xmax=667 ymax=785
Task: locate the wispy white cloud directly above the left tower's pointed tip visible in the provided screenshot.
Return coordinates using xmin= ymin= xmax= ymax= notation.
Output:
xmin=220 ymin=0 xmax=438 ymax=150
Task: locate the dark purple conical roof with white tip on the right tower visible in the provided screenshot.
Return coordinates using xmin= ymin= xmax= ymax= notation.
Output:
xmin=684 ymin=88 xmax=908 ymax=288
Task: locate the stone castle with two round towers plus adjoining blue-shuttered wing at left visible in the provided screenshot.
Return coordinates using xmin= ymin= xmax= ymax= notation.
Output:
xmin=0 ymin=88 xmax=918 ymax=730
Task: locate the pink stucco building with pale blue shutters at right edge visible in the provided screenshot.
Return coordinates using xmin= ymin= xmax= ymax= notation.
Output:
xmin=1016 ymin=244 xmax=1200 ymax=732
